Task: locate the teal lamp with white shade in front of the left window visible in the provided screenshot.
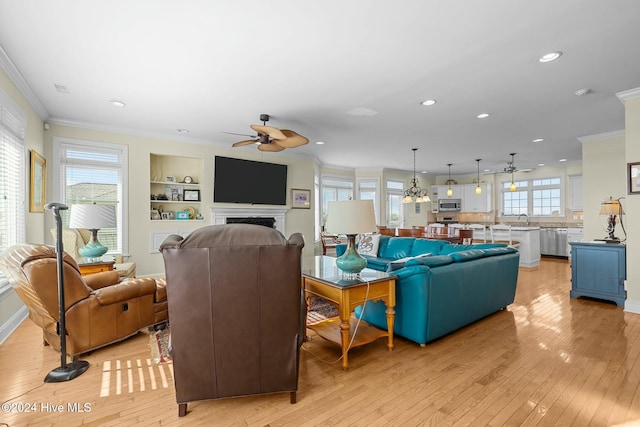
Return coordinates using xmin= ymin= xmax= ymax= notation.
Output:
xmin=69 ymin=204 xmax=116 ymax=258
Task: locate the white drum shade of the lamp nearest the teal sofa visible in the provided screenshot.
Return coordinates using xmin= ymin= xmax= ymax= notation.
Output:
xmin=326 ymin=200 xmax=376 ymax=234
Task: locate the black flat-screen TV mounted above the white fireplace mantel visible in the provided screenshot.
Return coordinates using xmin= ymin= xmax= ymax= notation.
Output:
xmin=213 ymin=156 xmax=287 ymax=205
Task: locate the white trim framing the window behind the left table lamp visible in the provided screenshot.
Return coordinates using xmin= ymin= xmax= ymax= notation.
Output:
xmin=53 ymin=137 xmax=130 ymax=257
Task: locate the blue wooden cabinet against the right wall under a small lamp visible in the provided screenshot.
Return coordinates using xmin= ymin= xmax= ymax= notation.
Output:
xmin=569 ymin=242 xmax=627 ymax=306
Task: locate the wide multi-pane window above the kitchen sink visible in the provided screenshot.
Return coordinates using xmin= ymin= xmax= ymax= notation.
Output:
xmin=502 ymin=177 xmax=562 ymax=216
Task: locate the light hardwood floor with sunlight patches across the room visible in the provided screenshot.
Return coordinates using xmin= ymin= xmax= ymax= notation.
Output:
xmin=0 ymin=259 xmax=640 ymax=427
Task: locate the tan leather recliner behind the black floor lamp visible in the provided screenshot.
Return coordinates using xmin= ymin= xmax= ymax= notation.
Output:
xmin=0 ymin=244 xmax=168 ymax=356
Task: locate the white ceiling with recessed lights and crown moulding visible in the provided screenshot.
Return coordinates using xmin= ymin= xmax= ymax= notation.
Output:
xmin=0 ymin=0 xmax=640 ymax=174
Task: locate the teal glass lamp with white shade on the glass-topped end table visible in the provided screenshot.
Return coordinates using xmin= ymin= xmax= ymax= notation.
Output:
xmin=326 ymin=200 xmax=376 ymax=275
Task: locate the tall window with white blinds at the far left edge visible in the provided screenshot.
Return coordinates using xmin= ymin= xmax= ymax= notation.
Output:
xmin=0 ymin=91 xmax=27 ymax=294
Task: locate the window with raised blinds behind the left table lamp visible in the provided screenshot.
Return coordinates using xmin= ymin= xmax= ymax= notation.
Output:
xmin=54 ymin=138 xmax=128 ymax=254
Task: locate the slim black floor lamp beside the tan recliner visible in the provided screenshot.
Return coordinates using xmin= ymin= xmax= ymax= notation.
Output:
xmin=44 ymin=203 xmax=89 ymax=383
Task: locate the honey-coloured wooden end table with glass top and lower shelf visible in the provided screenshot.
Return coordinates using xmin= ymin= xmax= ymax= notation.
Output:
xmin=302 ymin=256 xmax=396 ymax=369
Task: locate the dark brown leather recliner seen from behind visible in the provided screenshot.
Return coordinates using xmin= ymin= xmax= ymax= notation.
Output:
xmin=160 ymin=224 xmax=306 ymax=416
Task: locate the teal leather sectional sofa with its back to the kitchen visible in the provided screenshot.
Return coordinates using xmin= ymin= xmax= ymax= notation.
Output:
xmin=337 ymin=236 xmax=520 ymax=345
